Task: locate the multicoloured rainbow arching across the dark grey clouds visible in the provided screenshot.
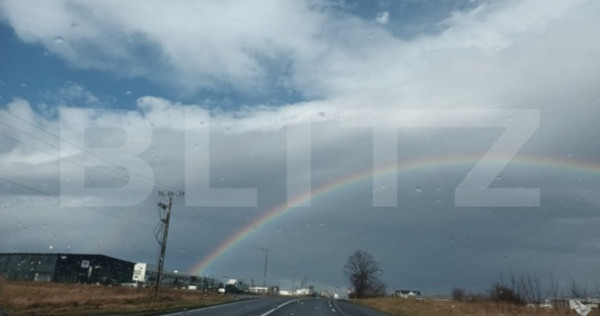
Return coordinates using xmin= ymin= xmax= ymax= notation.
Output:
xmin=191 ymin=156 xmax=600 ymax=275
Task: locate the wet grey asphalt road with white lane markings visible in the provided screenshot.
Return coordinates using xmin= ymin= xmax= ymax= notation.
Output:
xmin=163 ymin=298 xmax=389 ymax=316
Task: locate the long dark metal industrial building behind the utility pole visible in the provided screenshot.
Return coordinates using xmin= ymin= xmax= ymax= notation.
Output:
xmin=0 ymin=253 xmax=134 ymax=284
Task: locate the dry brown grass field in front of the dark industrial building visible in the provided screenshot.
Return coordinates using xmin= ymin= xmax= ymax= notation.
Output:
xmin=0 ymin=281 xmax=228 ymax=316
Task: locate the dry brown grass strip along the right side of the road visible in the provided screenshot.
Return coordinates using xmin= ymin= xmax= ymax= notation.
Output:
xmin=359 ymin=297 xmax=600 ymax=316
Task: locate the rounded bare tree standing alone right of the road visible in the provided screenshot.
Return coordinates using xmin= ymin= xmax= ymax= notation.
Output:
xmin=344 ymin=250 xmax=385 ymax=298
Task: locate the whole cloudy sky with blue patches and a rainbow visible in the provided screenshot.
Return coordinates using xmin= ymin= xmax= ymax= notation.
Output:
xmin=0 ymin=0 xmax=600 ymax=295
